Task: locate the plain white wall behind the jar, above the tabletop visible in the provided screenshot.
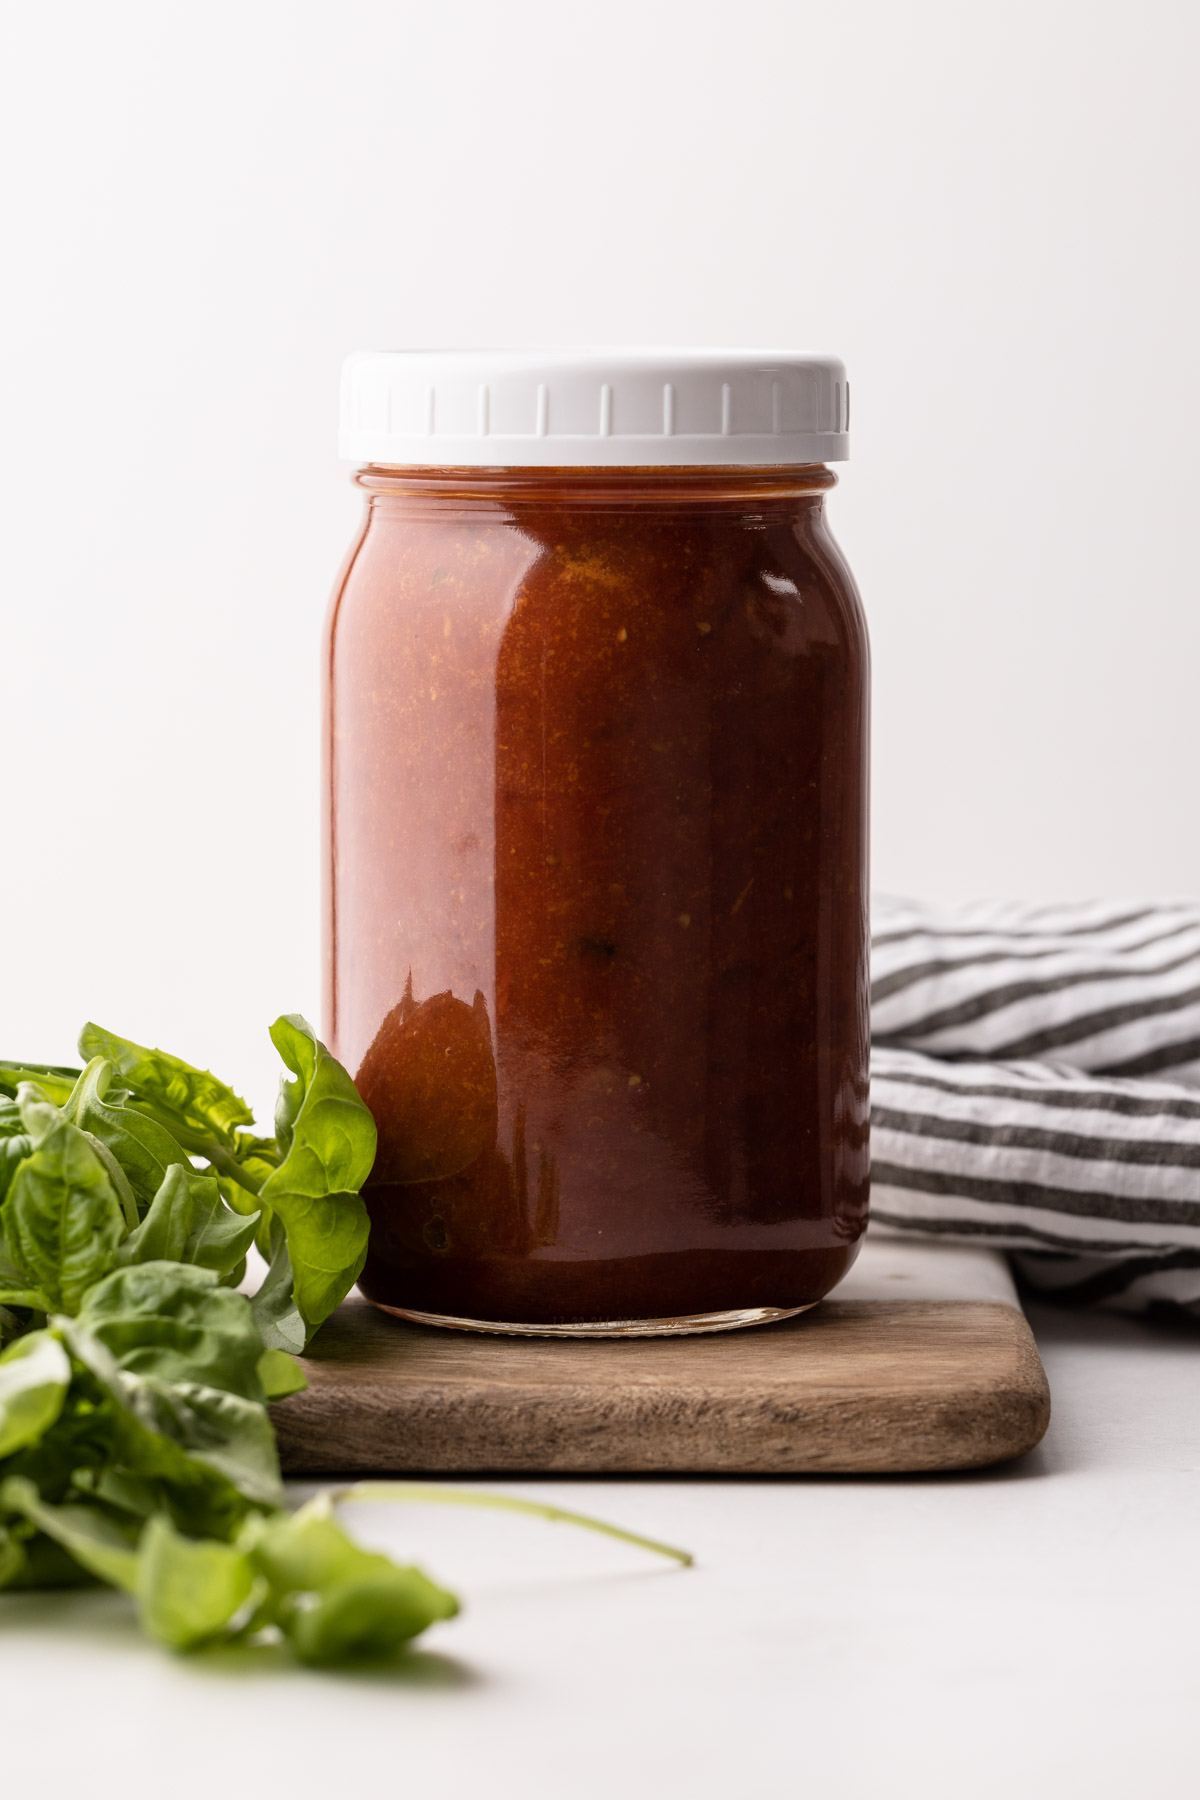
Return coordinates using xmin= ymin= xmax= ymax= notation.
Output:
xmin=0 ymin=0 xmax=1200 ymax=1103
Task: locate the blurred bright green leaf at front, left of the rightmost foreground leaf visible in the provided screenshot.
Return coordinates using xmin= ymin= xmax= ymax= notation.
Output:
xmin=137 ymin=1514 xmax=266 ymax=1651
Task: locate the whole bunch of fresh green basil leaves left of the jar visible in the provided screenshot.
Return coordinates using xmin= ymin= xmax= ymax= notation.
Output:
xmin=0 ymin=1017 xmax=457 ymax=1663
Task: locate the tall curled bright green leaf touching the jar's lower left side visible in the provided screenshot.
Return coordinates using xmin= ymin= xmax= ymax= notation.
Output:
xmin=261 ymin=1013 xmax=376 ymax=1337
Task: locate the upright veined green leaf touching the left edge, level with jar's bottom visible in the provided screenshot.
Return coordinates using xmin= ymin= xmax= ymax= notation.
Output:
xmin=0 ymin=1084 xmax=126 ymax=1312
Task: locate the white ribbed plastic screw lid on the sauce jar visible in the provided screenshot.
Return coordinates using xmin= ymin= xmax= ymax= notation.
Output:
xmin=340 ymin=349 xmax=849 ymax=468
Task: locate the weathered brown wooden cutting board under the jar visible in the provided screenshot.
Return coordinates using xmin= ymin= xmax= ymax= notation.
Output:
xmin=272 ymin=1237 xmax=1051 ymax=1476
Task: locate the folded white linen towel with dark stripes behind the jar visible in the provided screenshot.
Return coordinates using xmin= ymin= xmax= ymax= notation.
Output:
xmin=871 ymin=896 xmax=1200 ymax=1318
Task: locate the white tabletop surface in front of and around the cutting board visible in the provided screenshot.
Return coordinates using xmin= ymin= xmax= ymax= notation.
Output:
xmin=0 ymin=1309 xmax=1200 ymax=1800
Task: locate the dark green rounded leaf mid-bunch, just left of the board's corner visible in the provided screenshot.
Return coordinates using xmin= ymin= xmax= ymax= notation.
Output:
xmin=72 ymin=1260 xmax=264 ymax=1404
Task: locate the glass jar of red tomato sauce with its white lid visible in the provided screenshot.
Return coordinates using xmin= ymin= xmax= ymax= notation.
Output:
xmin=326 ymin=351 xmax=867 ymax=1336
